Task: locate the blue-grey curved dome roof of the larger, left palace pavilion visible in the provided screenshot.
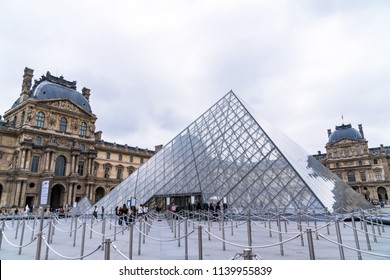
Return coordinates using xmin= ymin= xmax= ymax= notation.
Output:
xmin=31 ymin=81 xmax=92 ymax=113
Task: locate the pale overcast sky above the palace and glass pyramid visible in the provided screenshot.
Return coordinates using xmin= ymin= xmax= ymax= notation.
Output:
xmin=0 ymin=0 xmax=390 ymax=153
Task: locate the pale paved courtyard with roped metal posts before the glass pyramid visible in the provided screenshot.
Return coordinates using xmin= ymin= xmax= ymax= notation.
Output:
xmin=0 ymin=206 xmax=390 ymax=260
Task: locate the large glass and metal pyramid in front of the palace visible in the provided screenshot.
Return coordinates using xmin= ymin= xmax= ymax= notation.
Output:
xmin=90 ymin=91 xmax=371 ymax=213
